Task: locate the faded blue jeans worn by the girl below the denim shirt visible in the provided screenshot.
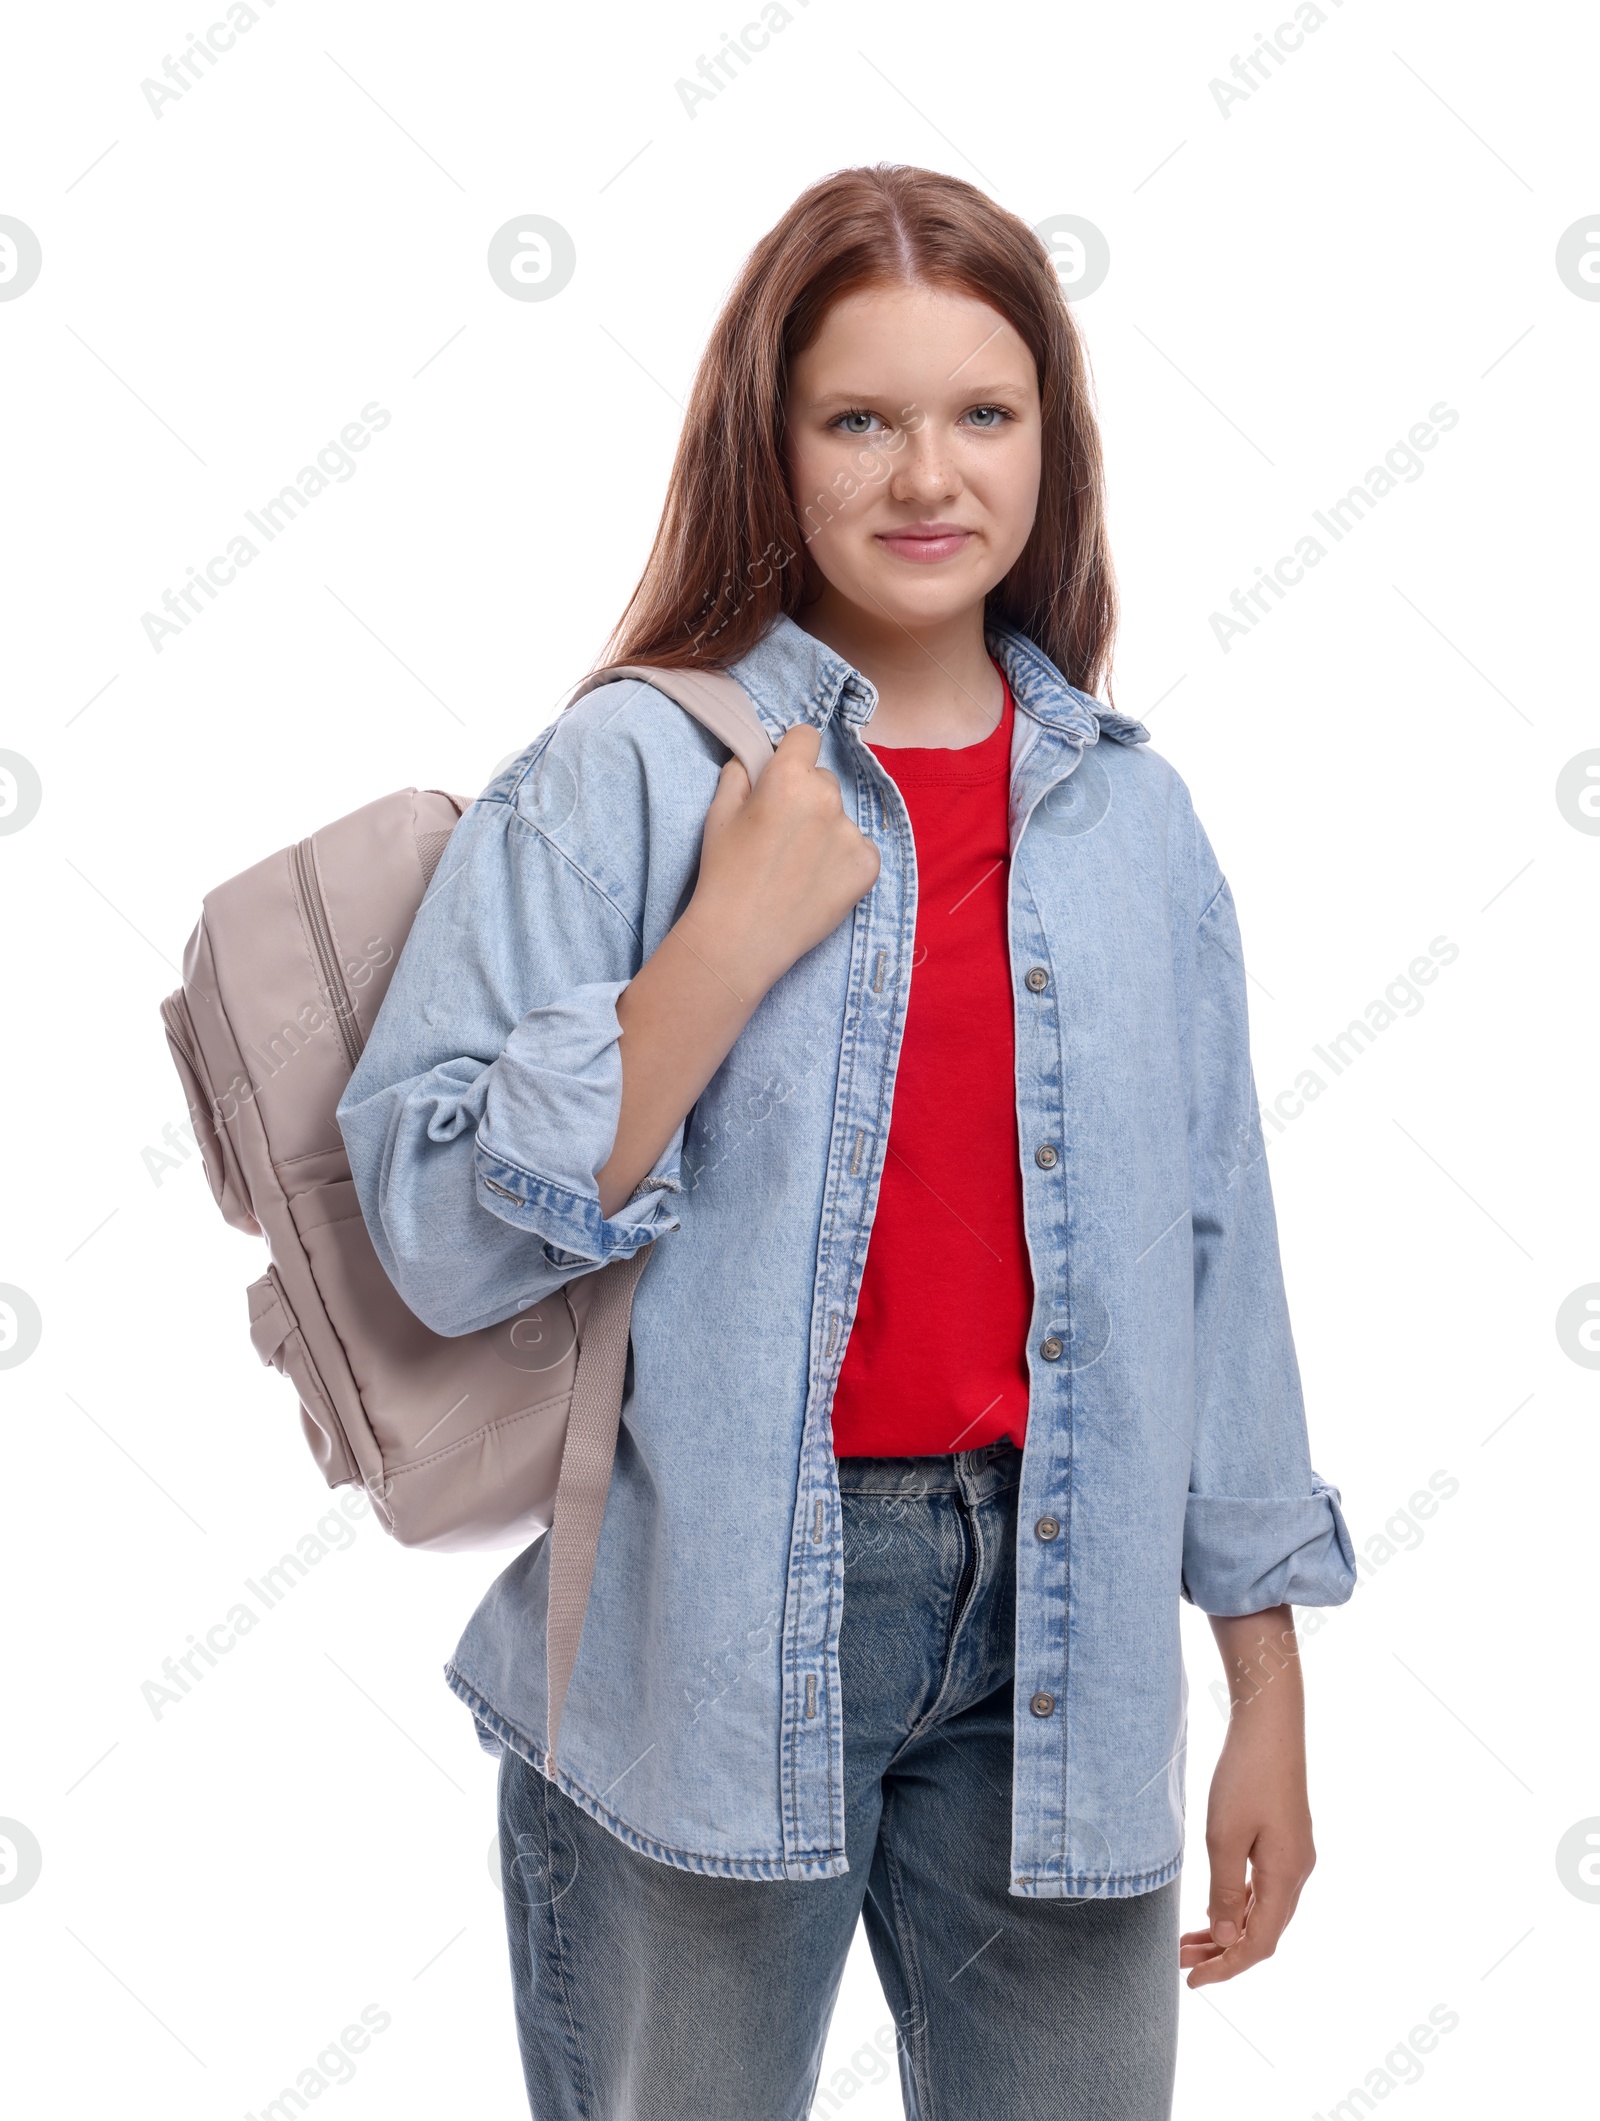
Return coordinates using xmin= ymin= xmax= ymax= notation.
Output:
xmin=501 ymin=1442 xmax=1178 ymax=2121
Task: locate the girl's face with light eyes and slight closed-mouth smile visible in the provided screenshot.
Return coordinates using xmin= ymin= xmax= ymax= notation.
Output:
xmin=785 ymin=286 xmax=1040 ymax=632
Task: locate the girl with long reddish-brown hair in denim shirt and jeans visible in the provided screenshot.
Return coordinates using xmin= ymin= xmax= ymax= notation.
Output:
xmin=340 ymin=168 xmax=1354 ymax=2121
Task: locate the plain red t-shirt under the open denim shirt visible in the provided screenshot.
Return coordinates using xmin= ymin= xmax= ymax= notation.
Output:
xmin=834 ymin=664 xmax=1033 ymax=1457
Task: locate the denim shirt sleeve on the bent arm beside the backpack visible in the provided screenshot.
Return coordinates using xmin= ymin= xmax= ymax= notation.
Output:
xmin=337 ymin=717 xmax=696 ymax=1334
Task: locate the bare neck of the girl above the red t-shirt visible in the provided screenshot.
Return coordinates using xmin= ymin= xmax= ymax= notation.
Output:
xmin=796 ymin=588 xmax=1006 ymax=749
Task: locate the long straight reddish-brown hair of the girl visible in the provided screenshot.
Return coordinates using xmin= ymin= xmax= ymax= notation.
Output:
xmin=607 ymin=163 xmax=1116 ymax=691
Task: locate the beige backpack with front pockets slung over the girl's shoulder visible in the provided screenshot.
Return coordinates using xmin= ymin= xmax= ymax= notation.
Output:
xmin=161 ymin=664 xmax=772 ymax=1752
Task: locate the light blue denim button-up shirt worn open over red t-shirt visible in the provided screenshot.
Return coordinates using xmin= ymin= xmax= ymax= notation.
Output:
xmin=340 ymin=619 xmax=1354 ymax=1898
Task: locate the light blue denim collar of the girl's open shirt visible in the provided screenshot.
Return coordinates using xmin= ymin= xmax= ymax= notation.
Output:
xmin=730 ymin=613 xmax=1150 ymax=744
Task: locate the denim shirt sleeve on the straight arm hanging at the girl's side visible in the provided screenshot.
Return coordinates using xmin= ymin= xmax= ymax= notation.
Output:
xmin=1182 ymin=852 xmax=1356 ymax=1614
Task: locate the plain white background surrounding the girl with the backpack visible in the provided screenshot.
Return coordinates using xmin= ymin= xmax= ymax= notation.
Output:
xmin=0 ymin=0 xmax=1600 ymax=2121
